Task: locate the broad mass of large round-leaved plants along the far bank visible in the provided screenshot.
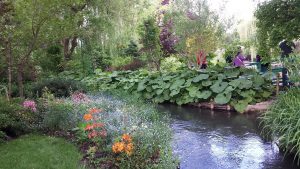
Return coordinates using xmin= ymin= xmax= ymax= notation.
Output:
xmin=88 ymin=68 xmax=272 ymax=112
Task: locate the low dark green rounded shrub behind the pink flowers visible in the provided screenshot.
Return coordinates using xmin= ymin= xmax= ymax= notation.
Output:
xmin=32 ymin=78 xmax=85 ymax=97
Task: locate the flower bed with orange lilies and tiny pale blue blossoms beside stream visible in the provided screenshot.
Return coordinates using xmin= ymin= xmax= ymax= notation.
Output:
xmin=40 ymin=93 xmax=176 ymax=168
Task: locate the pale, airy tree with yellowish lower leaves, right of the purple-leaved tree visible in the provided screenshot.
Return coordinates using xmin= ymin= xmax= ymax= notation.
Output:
xmin=168 ymin=0 xmax=224 ymax=65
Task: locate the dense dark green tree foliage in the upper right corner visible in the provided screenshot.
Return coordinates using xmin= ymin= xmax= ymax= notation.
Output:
xmin=255 ymin=0 xmax=300 ymax=58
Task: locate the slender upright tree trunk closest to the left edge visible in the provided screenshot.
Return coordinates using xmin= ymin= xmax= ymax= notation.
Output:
xmin=5 ymin=41 xmax=12 ymax=98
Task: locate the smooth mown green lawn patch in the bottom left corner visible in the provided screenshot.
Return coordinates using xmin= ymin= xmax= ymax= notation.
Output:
xmin=0 ymin=135 xmax=83 ymax=169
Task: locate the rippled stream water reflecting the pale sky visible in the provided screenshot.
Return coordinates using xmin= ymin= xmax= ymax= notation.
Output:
xmin=160 ymin=105 xmax=298 ymax=169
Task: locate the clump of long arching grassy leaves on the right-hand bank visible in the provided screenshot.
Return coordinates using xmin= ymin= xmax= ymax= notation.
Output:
xmin=261 ymin=88 xmax=300 ymax=165
